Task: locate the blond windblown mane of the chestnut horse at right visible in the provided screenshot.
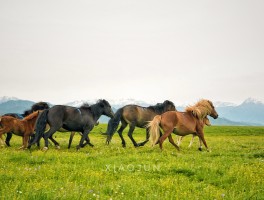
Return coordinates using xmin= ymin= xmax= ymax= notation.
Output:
xmin=185 ymin=99 xmax=213 ymax=119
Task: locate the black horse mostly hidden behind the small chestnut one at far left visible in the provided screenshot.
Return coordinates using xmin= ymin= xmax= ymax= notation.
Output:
xmin=3 ymin=101 xmax=49 ymax=147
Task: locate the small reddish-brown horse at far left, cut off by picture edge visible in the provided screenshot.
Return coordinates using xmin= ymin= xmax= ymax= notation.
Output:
xmin=0 ymin=111 xmax=39 ymax=149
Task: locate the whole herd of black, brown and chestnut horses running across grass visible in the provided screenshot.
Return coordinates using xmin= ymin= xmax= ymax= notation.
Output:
xmin=0 ymin=99 xmax=218 ymax=151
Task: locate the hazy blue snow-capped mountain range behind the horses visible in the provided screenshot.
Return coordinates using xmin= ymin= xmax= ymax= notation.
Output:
xmin=0 ymin=96 xmax=264 ymax=126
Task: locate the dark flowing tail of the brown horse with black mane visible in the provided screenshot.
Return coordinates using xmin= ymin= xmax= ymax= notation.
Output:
xmin=106 ymin=108 xmax=123 ymax=144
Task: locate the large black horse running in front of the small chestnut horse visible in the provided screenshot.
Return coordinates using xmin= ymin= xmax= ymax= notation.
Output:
xmin=29 ymin=100 xmax=114 ymax=151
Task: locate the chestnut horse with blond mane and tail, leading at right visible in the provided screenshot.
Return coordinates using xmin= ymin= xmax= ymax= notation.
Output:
xmin=147 ymin=99 xmax=218 ymax=150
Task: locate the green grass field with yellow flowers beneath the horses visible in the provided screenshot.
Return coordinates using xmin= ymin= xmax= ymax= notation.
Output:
xmin=0 ymin=124 xmax=264 ymax=200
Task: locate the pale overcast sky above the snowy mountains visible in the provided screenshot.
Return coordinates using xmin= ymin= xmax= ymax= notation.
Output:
xmin=0 ymin=0 xmax=264 ymax=104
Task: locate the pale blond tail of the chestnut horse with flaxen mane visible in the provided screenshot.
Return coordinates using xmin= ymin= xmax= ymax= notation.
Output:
xmin=147 ymin=115 xmax=161 ymax=146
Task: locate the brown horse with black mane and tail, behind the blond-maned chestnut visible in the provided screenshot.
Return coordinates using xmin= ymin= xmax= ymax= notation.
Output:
xmin=106 ymin=100 xmax=176 ymax=147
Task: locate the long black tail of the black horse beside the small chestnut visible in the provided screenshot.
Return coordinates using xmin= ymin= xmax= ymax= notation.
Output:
xmin=30 ymin=109 xmax=49 ymax=146
